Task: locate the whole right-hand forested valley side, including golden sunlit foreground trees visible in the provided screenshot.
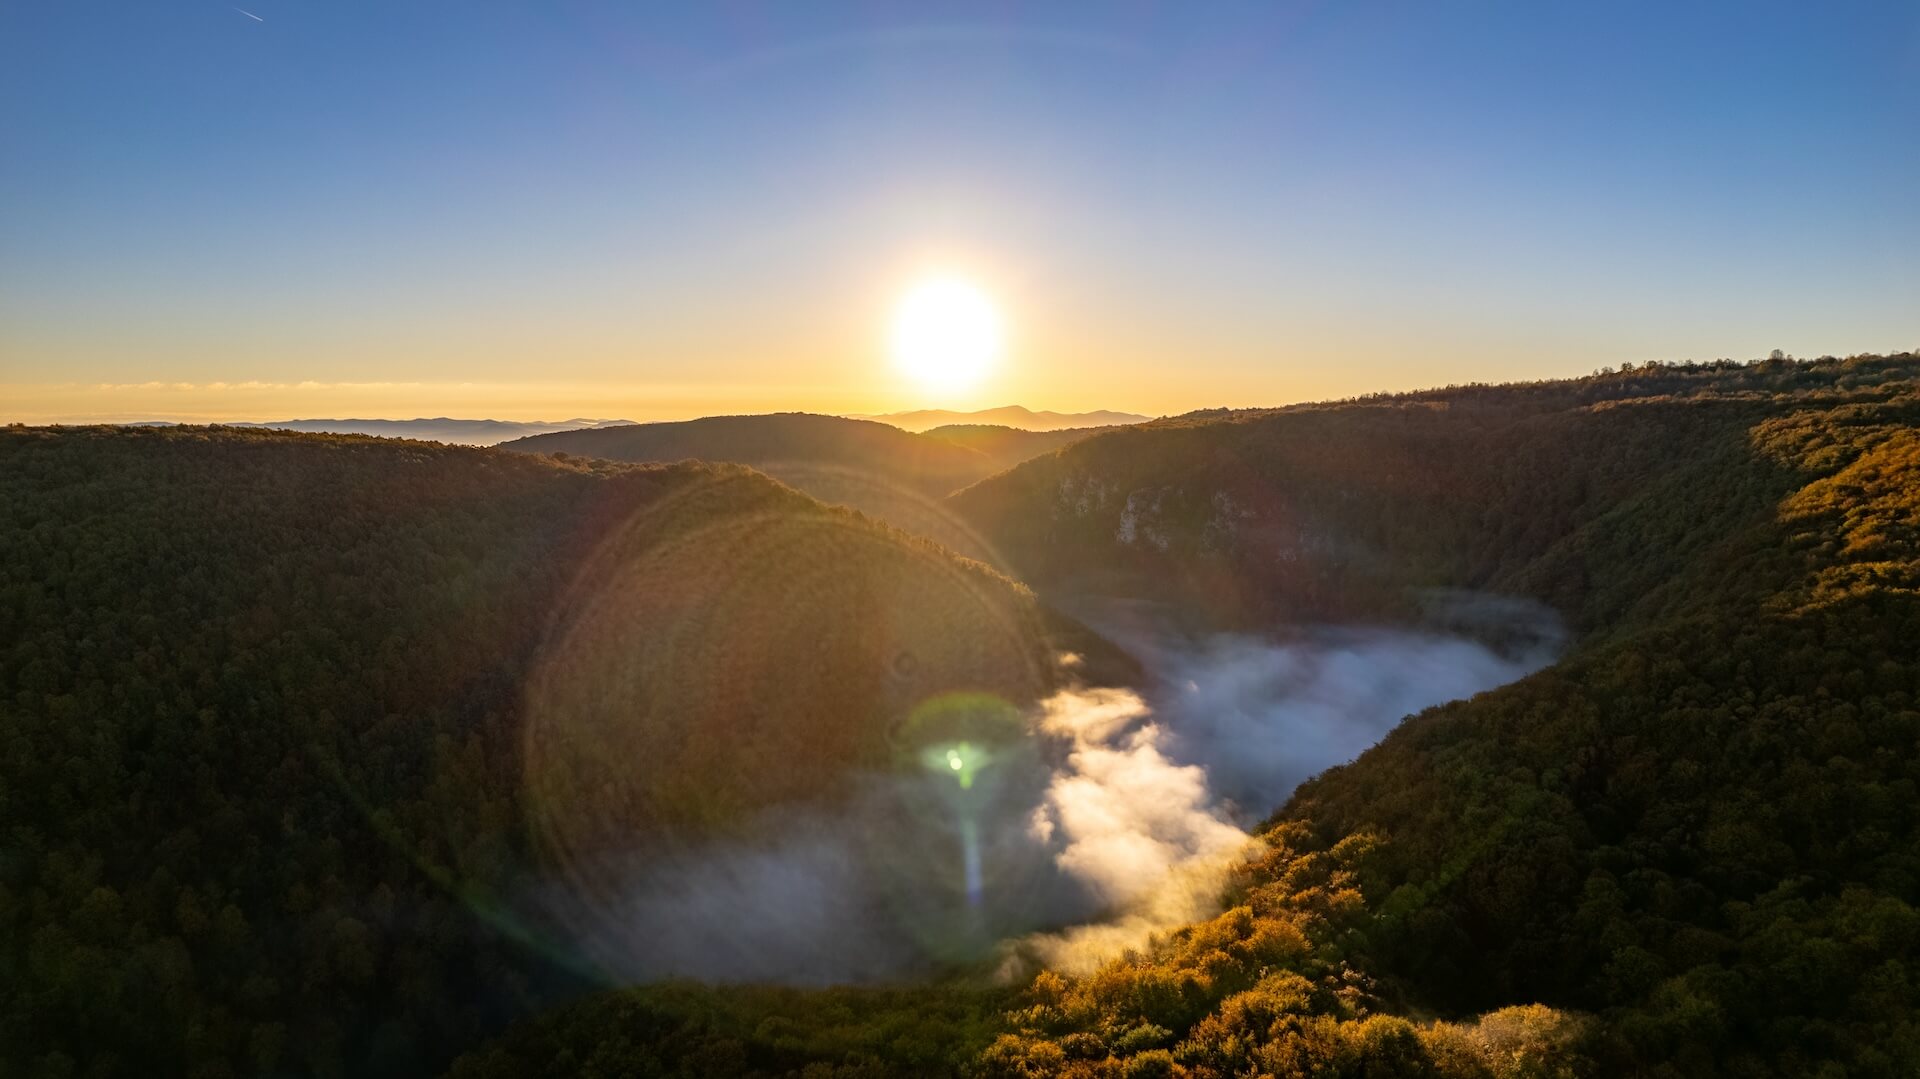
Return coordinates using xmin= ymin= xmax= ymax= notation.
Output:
xmin=461 ymin=355 xmax=1920 ymax=1077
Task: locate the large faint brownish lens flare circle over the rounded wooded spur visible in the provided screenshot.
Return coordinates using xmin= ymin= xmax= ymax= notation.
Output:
xmin=518 ymin=467 xmax=1050 ymax=983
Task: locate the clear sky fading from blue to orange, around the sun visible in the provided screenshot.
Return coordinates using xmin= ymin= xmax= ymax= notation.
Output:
xmin=0 ymin=0 xmax=1920 ymax=419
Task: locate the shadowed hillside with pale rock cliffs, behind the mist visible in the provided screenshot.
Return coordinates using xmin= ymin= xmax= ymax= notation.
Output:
xmin=950 ymin=357 xmax=1916 ymax=630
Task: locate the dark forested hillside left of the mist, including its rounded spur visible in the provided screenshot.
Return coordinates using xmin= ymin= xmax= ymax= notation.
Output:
xmin=0 ymin=426 xmax=1052 ymax=1075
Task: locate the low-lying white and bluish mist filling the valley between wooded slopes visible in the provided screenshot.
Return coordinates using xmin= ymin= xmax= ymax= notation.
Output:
xmin=545 ymin=606 xmax=1559 ymax=985
